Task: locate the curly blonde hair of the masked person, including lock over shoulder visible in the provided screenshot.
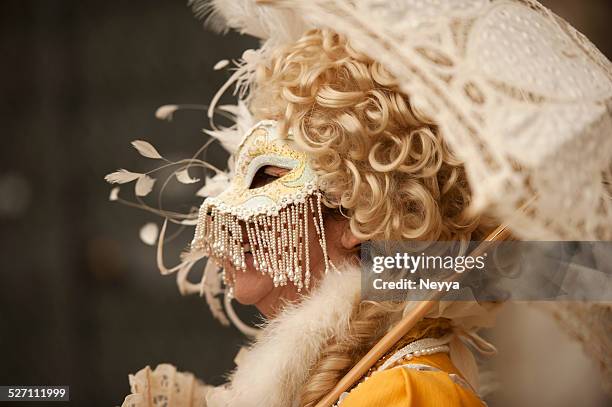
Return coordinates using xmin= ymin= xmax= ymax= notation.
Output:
xmin=250 ymin=30 xmax=483 ymax=406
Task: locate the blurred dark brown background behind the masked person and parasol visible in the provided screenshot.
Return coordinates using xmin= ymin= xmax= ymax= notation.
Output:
xmin=0 ymin=0 xmax=612 ymax=406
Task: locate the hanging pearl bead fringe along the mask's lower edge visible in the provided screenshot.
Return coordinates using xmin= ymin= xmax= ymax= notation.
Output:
xmin=191 ymin=192 xmax=330 ymax=295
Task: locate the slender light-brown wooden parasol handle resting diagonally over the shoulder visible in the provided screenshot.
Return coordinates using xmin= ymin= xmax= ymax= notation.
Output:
xmin=316 ymin=226 xmax=510 ymax=407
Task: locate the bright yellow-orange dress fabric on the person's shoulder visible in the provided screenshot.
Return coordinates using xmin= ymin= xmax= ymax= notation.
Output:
xmin=338 ymin=353 xmax=485 ymax=407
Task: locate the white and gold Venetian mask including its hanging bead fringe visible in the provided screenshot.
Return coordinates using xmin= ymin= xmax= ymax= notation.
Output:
xmin=191 ymin=120 xmax=330 ymax=292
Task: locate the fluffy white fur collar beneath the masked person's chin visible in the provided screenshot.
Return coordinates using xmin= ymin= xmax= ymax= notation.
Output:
xmin=207 ymin=269 xmax=361 ymax=407
